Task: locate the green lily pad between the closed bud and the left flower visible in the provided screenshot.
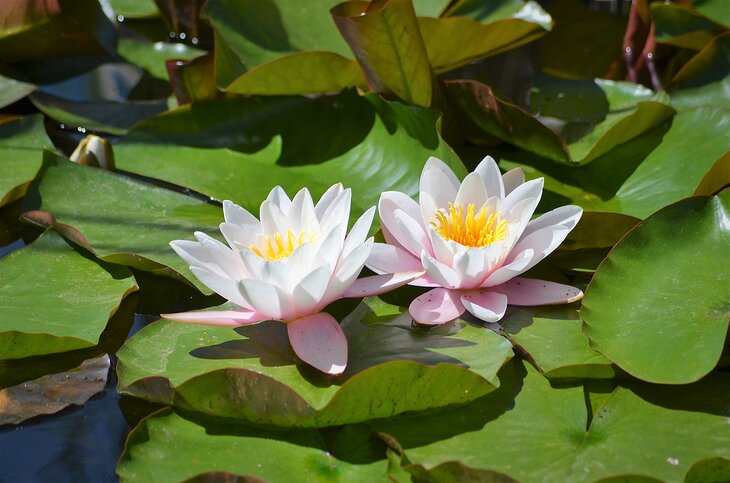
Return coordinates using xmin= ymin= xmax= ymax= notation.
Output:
xmin=24 ymin=152 xmax=223 ymax=294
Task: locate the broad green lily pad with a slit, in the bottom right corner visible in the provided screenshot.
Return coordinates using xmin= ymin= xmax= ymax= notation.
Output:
xmin=372 ymin=367 xmax=730 ymax=483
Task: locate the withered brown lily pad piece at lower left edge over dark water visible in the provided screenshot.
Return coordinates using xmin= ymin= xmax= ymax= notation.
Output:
xmin=0 ymin=354 xmax=110 ymax=426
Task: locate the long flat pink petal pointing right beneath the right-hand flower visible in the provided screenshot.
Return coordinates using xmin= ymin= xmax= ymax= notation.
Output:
xmin=492 ymin=277 xmax=583 ymax=306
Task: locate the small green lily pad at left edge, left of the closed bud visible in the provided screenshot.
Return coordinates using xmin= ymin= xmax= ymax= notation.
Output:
xmin=0 ymin=116 xmax=53 ymax=210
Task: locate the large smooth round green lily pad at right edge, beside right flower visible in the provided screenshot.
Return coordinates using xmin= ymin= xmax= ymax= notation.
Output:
xmin=581 ymin=190 xmax=730 ymax=384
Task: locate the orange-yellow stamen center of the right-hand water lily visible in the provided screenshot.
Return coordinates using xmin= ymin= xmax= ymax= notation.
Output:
xmin=431 ymin=203 xmax=507 ymax=247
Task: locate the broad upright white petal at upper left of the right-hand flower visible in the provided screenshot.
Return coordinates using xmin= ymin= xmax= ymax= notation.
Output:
xmin=418 ymin=157 xmax=460 ymax=227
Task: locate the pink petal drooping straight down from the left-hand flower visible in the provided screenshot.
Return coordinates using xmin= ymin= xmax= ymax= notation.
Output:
xmin=287 ymin=312 xmax=347 ymax=375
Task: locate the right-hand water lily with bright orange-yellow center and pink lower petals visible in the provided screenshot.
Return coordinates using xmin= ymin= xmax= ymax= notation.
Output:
xmin=366 ymin=156 xmax=583 ymax=324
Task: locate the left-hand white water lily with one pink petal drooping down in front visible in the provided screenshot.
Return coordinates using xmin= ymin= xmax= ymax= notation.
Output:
xmin=162 ymin=184 xmax=422 ymax=374
